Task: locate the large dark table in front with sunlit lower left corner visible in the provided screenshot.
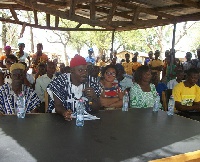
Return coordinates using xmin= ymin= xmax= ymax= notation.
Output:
xmin=0 ymin=109 xmax=200 ymax=162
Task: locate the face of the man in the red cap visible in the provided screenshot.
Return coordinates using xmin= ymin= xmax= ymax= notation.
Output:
xmin=71 ymin=65 xmax=88 ymax=83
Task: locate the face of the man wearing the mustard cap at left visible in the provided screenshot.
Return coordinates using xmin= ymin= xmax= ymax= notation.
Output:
xmin=11 ymin=69 xmax=25 ymax=87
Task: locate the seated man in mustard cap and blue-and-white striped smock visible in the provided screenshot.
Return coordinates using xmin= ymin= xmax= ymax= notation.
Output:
xmin=0 ymin=63 xmax=40 ymax=115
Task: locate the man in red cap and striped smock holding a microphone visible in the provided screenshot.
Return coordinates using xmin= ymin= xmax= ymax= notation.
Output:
xmin=47 ymin=55 xmax=101 ymax=120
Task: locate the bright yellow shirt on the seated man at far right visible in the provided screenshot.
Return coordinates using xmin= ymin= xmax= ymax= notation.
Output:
xmin=172 ymin=82 xmax=200 ymax=106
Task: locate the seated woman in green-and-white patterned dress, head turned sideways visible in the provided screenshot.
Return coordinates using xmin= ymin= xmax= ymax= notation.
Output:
xmin=130 ymin=65 xmax=160 ymax=108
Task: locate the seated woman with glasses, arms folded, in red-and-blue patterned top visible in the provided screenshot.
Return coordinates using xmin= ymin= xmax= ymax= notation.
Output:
xmin=100 ymin=65 xmax=124 ymax=108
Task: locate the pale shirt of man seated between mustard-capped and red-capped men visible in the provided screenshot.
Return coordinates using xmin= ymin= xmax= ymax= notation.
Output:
xmin=35 ymin=74 xmax=56 ymax=102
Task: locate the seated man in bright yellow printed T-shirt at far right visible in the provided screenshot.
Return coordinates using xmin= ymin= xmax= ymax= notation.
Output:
xmin=172 ymin=68 xmax=200 ymax=112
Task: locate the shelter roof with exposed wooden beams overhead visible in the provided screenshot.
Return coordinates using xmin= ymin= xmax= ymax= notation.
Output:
xmin=0 ymin=0 xmax=200 ymax=31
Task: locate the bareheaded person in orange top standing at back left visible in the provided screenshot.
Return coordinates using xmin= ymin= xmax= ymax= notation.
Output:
xmin=32 ymin=43 xmax=48 ymax=74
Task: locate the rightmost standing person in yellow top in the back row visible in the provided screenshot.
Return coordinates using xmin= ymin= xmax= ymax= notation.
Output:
xmin=149 ymin=50 xmax=163 ymax=81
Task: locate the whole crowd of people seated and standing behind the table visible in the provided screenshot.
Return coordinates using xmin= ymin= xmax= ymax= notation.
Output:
xmin=0 ymin=43 xmax=200 ymax=120
